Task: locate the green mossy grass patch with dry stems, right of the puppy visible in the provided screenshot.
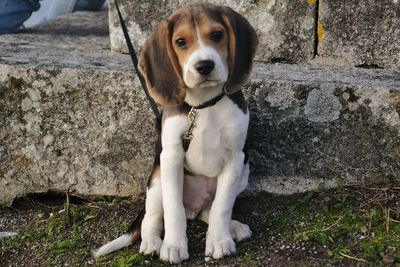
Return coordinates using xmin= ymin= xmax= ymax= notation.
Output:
xmin=250 ymin=188 xmax=400 ymax=266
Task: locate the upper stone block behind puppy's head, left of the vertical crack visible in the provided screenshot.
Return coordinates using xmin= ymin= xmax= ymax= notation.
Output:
xmin=109 ymin=0 xmax=316 ymax=62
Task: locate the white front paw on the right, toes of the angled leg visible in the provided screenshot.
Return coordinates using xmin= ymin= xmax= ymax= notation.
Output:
xmin=206 ymin=235 xmax=236 ymax=259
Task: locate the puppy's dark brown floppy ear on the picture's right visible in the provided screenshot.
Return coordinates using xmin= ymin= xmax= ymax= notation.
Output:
xmin=220 ymin=6 xmax=258 ymax=95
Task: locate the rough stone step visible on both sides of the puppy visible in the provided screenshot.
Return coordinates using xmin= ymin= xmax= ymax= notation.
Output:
xmin=0 ymin=10 xmax=400 ymax=204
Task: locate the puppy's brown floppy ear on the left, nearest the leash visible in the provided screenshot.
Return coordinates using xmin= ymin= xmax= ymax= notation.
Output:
xmin=139 ymin=20 xmax=186 ymax=107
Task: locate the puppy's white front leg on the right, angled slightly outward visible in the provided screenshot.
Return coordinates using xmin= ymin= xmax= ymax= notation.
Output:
xmin=205 ymin=152 xmax=244 ymax=259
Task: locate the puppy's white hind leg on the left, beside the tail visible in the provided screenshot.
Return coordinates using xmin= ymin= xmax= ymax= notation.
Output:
xmin=139 ymin=166 xmax=163 ymax=255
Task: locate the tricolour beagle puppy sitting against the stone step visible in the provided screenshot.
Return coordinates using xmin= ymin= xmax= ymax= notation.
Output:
xmin=94 ymin=3 xmax=258 ymax=263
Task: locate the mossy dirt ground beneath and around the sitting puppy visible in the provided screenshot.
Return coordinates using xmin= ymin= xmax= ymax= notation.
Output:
xmin=0 ymin=185 xmax=400 ymax=266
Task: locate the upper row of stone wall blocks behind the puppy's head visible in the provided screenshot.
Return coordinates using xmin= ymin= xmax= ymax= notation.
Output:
xmin=109 ymin=0 xmax=400 ymax=69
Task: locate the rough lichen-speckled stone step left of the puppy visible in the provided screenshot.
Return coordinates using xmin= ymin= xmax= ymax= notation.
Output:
xmin=0 ymin=13 xmax=155 ymax=205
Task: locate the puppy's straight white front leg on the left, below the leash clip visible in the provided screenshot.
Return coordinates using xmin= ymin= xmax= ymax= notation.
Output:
xmin=160 ymin=117 xmax=189 ymax=263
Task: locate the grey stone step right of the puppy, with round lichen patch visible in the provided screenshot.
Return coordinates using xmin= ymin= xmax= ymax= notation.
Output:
xmin=245 ymin=65 xmax=400 ymax=193
